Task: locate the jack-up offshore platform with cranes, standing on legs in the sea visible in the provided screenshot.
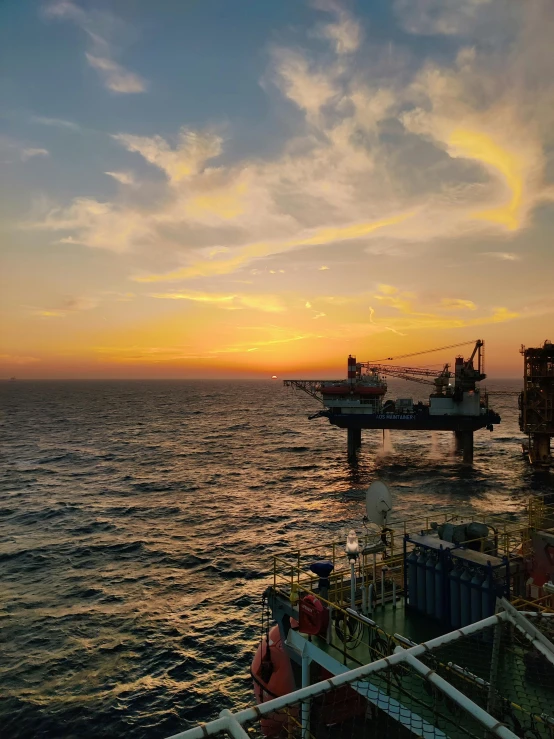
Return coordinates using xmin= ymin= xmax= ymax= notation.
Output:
xmin=284 ymin=339 xmax=498 ymax=462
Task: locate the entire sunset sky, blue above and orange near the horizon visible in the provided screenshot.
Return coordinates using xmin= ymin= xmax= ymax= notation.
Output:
xmin=0 ymin=0 xmax=554 ymax=378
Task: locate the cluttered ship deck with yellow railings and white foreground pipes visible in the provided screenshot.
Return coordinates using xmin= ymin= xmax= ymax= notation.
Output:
xmin=173 ymin=497 xmax=554 ymax=739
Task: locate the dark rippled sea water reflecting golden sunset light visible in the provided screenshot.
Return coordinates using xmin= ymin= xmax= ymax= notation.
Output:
xmin=0 ymin=381 xmax=554 ymax=739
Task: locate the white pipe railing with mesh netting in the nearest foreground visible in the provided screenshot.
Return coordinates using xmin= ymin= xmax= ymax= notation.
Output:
xmin=174 ymin=612 xmax=554 ymax=739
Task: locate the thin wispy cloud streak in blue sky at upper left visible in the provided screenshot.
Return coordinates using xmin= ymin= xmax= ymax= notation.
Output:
xmin=45 ymin=0 xmax=148 ymax=94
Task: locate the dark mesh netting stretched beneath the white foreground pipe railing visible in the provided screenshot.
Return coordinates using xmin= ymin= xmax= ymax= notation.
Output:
xmin=245 ymin=619 xmax=554 ymax=739
